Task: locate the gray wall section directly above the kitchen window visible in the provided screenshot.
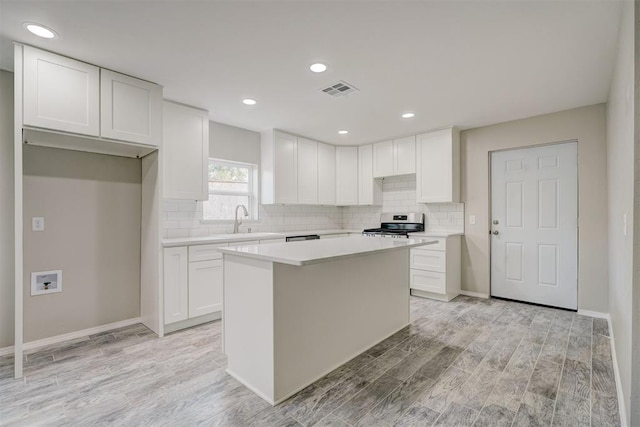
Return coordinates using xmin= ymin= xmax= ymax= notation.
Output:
xmin=209 ymin=122 xmax=260 ymax=165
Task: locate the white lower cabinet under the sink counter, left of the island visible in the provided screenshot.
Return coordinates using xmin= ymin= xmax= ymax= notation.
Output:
xmin=163 ymin=243 xmax=227 ymax=329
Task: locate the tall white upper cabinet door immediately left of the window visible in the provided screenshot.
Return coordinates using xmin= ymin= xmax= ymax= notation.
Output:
xmin=162 ymin=101 xmax=209 ymax=200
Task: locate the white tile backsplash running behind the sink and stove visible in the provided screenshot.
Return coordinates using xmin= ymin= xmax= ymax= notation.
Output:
xmin=162 ymin=175 xmax=464 ymax=238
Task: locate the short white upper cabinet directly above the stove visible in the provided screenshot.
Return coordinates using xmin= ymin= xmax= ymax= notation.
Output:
xmin=373 ymin=136 xmax=416 ymax=178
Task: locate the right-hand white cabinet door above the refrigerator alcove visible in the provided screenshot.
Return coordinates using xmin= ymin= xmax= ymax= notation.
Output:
xmin=100 ymin=69 xmax=162 ymax=146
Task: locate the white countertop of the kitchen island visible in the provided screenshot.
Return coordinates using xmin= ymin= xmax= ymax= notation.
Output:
xmin=218 ymin=236 xmax=437 ymax=266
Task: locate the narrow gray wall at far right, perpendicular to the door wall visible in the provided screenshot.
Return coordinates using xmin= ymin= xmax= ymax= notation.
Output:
xmin=607 ymin=2 xmax=634 ymax=419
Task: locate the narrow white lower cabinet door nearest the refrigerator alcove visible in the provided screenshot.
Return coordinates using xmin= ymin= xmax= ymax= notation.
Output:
xmin=163 ymin=246 xmax=189 ymax=325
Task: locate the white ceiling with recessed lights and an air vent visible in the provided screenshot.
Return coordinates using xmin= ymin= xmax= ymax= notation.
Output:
xmin=0 ymin=0 xmax=621 ymax=144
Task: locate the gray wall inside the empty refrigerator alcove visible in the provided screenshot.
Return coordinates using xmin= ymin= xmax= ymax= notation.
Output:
xmin=24 ymin=146 xmax=141 ymax=342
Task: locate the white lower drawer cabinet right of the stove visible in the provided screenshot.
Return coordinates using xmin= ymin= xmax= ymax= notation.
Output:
xmin=409 ymin=236 xmax=461 ymax=301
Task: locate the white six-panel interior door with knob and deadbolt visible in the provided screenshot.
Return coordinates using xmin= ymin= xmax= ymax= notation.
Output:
xmin=491 ymin=142 xmax=578 ymax=310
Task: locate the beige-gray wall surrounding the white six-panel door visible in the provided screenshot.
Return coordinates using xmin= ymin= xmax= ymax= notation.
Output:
xmin=460 ymin=104 xmax=608 ymax=313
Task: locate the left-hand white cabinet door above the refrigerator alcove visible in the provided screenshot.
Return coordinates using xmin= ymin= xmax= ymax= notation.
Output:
xmin=23 ymin=46 xmax=100 ymax=136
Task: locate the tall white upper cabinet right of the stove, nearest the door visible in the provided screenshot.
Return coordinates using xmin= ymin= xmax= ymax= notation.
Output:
xmin=416 ymin=128 xmax=460 ymax=203
